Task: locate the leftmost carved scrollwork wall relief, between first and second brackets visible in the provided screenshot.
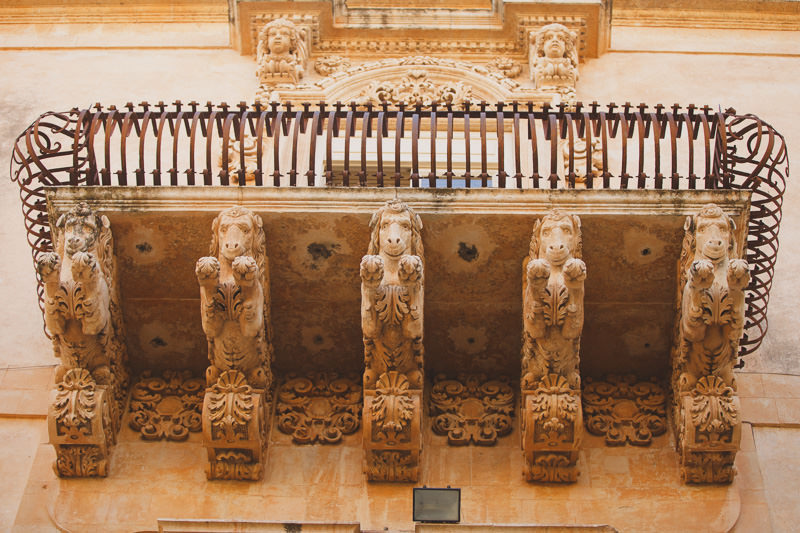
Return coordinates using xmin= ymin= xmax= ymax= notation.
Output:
xmin=129 ymin=370 xmax=205 ymax=441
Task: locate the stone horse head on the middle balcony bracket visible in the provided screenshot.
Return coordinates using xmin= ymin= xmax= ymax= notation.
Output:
xmin=367 ymin=200 xmax=423 ymax=257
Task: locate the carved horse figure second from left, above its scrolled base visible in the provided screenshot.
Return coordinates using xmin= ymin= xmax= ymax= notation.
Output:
xmin=196 ymin=206 xmax=272 ymax=388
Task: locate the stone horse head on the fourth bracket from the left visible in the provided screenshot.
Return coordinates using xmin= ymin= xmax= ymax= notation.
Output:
xmin=530 ymin=209 xmax=582 ymax=266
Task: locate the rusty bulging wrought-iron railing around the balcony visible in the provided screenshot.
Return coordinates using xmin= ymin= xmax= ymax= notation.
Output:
xmin=11 ymin=102 xmax=788 ymax=362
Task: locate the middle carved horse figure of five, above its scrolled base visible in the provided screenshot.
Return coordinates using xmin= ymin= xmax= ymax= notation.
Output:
xmin=361 ymin=200 xmax=423 ymax=389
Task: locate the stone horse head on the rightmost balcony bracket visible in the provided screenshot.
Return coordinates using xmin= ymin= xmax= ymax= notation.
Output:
xmin=683 ymin=204 xmax=736 ymax=263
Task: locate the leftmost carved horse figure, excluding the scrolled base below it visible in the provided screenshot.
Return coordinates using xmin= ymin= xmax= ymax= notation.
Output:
xmin=36 ymin=203 xmax=127 ymax=385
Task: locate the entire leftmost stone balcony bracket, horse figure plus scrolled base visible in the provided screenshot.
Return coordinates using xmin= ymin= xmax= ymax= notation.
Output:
xmin=36 ymin=203 xmax=128 ymax=477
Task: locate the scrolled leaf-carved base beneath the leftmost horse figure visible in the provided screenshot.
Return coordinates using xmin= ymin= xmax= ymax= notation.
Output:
xmin=47 ymin=368 xmax=116 ymax=477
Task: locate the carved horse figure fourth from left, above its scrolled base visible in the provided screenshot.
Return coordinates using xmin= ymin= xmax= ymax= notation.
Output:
xmin=522 ymin=210 xmax=586 ymax=390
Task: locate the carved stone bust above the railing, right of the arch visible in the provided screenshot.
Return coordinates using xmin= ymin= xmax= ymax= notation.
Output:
xmin=529 ymin=23 xmax=578 ymax=100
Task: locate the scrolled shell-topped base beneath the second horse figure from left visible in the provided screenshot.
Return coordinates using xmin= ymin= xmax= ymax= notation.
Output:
xmin=203 ymin=370 xmax=267 ymax=480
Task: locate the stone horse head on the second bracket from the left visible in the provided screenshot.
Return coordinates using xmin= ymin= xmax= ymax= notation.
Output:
xmin=210 ymin=206 xmax=266 ymax=269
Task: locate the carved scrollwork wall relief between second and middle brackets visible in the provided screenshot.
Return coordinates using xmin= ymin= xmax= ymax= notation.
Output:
xmin=277 ymin=373 xmax=361 ymax=444
